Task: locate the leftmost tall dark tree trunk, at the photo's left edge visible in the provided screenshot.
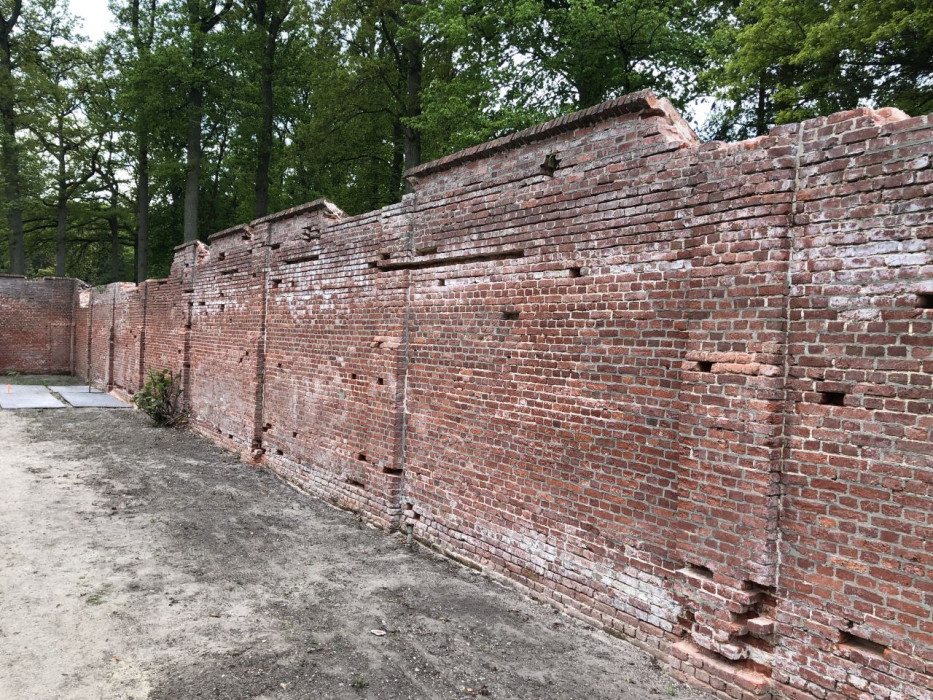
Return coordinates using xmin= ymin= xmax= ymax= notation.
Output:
xmin=0 ymin=8 xmax=26 ymax=275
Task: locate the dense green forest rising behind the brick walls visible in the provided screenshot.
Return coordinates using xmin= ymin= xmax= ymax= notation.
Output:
xmin=0 ymin=0 xmax=933 ymax=284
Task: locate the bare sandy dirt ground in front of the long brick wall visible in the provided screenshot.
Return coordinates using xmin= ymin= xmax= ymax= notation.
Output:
xmin=0 ymin=409 xmax=707 ymax=700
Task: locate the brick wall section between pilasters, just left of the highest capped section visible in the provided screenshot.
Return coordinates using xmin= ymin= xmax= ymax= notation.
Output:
xmin=257 ymin=202 xmax=406 ymax=526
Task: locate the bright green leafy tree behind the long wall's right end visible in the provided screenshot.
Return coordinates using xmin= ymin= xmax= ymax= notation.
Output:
xmin=705 ymin=0 xmax=933 ymax=138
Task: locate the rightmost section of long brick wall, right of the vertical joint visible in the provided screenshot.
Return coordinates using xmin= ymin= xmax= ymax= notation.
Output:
xmin=775 ymin=110 xmax=933 ymax=698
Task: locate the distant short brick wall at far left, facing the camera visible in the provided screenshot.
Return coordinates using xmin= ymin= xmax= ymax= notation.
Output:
xmin=0 ymin=275 xmax=78 ymax=374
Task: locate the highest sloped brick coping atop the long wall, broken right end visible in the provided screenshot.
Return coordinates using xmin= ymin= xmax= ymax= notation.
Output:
xmin=405 ymin=90 xmax=699 ymax=180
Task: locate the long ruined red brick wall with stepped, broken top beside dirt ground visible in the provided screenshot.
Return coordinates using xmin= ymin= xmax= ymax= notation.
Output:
xmin=3 ymin=93 xmax=933 ymax=700
